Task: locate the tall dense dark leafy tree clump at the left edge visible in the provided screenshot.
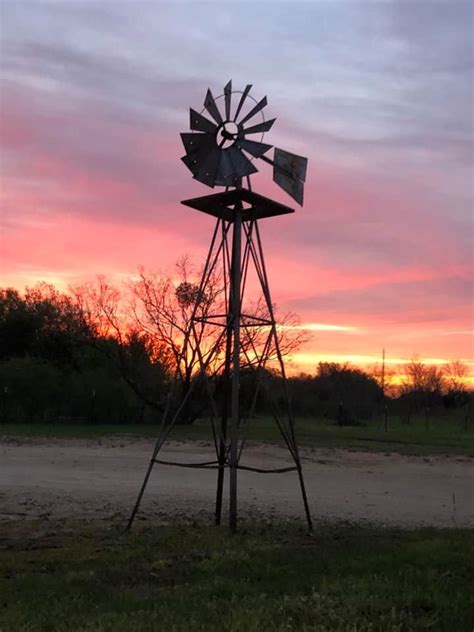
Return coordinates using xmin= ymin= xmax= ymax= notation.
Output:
xmin=0 ymin=283 xmax=165 ymax=421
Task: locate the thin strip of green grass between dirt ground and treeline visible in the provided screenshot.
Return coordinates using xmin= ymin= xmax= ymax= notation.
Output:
xmin=0 ymin=418 xmax=474 ymax=456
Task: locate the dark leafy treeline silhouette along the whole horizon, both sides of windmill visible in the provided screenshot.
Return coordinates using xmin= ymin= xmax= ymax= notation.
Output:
xmin=0 ymin=281 xmax=472 ymax=425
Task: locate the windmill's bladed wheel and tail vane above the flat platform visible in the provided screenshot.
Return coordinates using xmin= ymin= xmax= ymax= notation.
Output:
xmin=181 ymin=81 xmax=308 ymax=205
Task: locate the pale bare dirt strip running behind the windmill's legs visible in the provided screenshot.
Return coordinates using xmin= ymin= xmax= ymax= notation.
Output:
xmin=0 ymin=439 xmax=474 ymax=543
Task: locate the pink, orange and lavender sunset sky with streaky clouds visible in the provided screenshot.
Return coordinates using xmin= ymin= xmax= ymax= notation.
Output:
xmin=0 ymin=0 xmax=474 ymax=371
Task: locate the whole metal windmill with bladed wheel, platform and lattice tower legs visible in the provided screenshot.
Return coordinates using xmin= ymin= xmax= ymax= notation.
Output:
xmin=128 ymin=81 xmax=312 ymax=531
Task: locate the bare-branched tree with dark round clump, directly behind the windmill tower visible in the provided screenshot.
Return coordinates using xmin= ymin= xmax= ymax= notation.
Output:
xmin=130 ymin=256 xmax=308 ymax=416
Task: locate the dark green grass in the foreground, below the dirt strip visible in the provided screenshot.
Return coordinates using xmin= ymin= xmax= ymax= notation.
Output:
xmin=0 ymin=526 xmax=474 ymax=632
